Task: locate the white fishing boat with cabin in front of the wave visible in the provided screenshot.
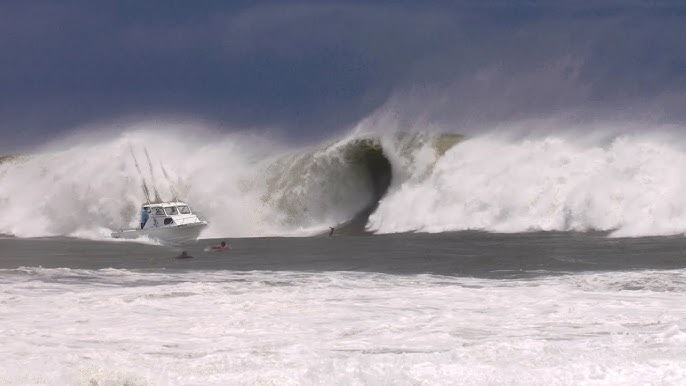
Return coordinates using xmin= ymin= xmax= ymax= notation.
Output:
xmin=112 ymin=201 xmax=207 ymax=245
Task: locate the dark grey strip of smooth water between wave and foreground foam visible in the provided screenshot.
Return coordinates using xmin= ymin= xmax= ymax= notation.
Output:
xmin=0 ymin=232 xmax=686 ymax=278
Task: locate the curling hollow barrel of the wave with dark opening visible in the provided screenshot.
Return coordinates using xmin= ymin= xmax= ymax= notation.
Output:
xmin=253 ymin=134 xmax=462 ymax=233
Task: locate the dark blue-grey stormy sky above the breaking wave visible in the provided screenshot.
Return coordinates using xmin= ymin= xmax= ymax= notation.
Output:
xmin=0 ymin=0 xmax=686 ymax=153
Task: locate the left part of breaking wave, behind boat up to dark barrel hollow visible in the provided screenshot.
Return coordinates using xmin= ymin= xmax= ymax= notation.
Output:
xmin=0 ymin=127 xmax=388 ymax=239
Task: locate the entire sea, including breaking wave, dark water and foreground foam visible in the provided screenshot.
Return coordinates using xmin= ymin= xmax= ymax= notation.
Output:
xmin=0 ymin=127 xmax=686 ymax=386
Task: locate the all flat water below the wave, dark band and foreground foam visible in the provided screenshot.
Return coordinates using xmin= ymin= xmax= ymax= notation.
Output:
xmin=0 ymin=231 xmax=686 ymax=385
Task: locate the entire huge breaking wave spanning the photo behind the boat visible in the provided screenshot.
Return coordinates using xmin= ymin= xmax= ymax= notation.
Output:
xmin=0 ymin=130 xmax=686 ymax=238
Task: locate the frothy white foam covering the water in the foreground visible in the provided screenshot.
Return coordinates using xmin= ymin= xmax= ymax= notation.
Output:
xmin=0 ymin=268 xmax=686 ymax=385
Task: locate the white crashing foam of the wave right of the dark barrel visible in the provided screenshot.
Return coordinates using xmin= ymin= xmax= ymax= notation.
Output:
xmin=368 ymin=135 xmax=686 ymax=236
